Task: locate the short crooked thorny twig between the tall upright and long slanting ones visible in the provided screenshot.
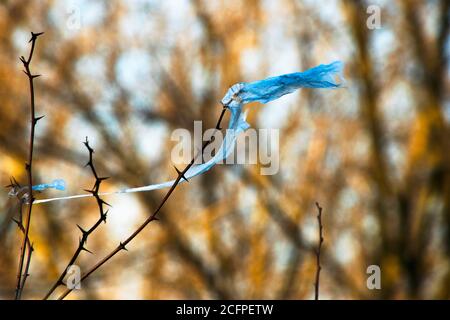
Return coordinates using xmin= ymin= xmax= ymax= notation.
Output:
xmin=44 ymin=137 xmax=109 ymax=300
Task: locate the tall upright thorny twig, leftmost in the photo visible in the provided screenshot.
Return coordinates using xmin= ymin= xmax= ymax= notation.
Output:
xmin=15 ymin=32 xmax=43 ymax=300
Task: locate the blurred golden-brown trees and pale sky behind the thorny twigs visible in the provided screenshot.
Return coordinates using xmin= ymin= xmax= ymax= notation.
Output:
xmin=0 ymin=0 xmax=450 ymax=299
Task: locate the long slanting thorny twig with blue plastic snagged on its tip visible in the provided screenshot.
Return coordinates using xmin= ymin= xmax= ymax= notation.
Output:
xmin=58 ymin=106 xmax=227 ymax=300
